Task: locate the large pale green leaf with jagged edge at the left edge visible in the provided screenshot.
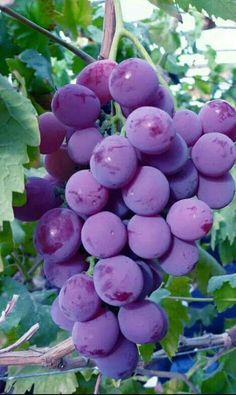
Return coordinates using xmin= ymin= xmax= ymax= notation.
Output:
xmin=0 ymin=75 xmax=40 ymax=226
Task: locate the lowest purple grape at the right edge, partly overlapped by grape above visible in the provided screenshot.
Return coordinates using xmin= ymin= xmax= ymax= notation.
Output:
xmin=197 ymin=173 xmax=235 ymax=209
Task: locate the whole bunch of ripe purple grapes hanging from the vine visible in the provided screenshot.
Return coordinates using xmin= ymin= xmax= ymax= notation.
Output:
xmin=15 ymin=58 xmax=236 ymax=379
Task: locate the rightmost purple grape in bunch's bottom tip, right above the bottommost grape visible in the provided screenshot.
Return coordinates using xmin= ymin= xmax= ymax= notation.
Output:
xmin=118 ymin=300 xmax=168 ymax=344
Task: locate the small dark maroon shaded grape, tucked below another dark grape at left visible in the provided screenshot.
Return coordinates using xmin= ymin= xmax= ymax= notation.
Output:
xmin=44 ymin=146 xmax=76 ymax=181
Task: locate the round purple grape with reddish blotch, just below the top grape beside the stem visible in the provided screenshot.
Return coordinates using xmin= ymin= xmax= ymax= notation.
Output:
xmin=125 ymin=107 xmax=175 ymax=154
